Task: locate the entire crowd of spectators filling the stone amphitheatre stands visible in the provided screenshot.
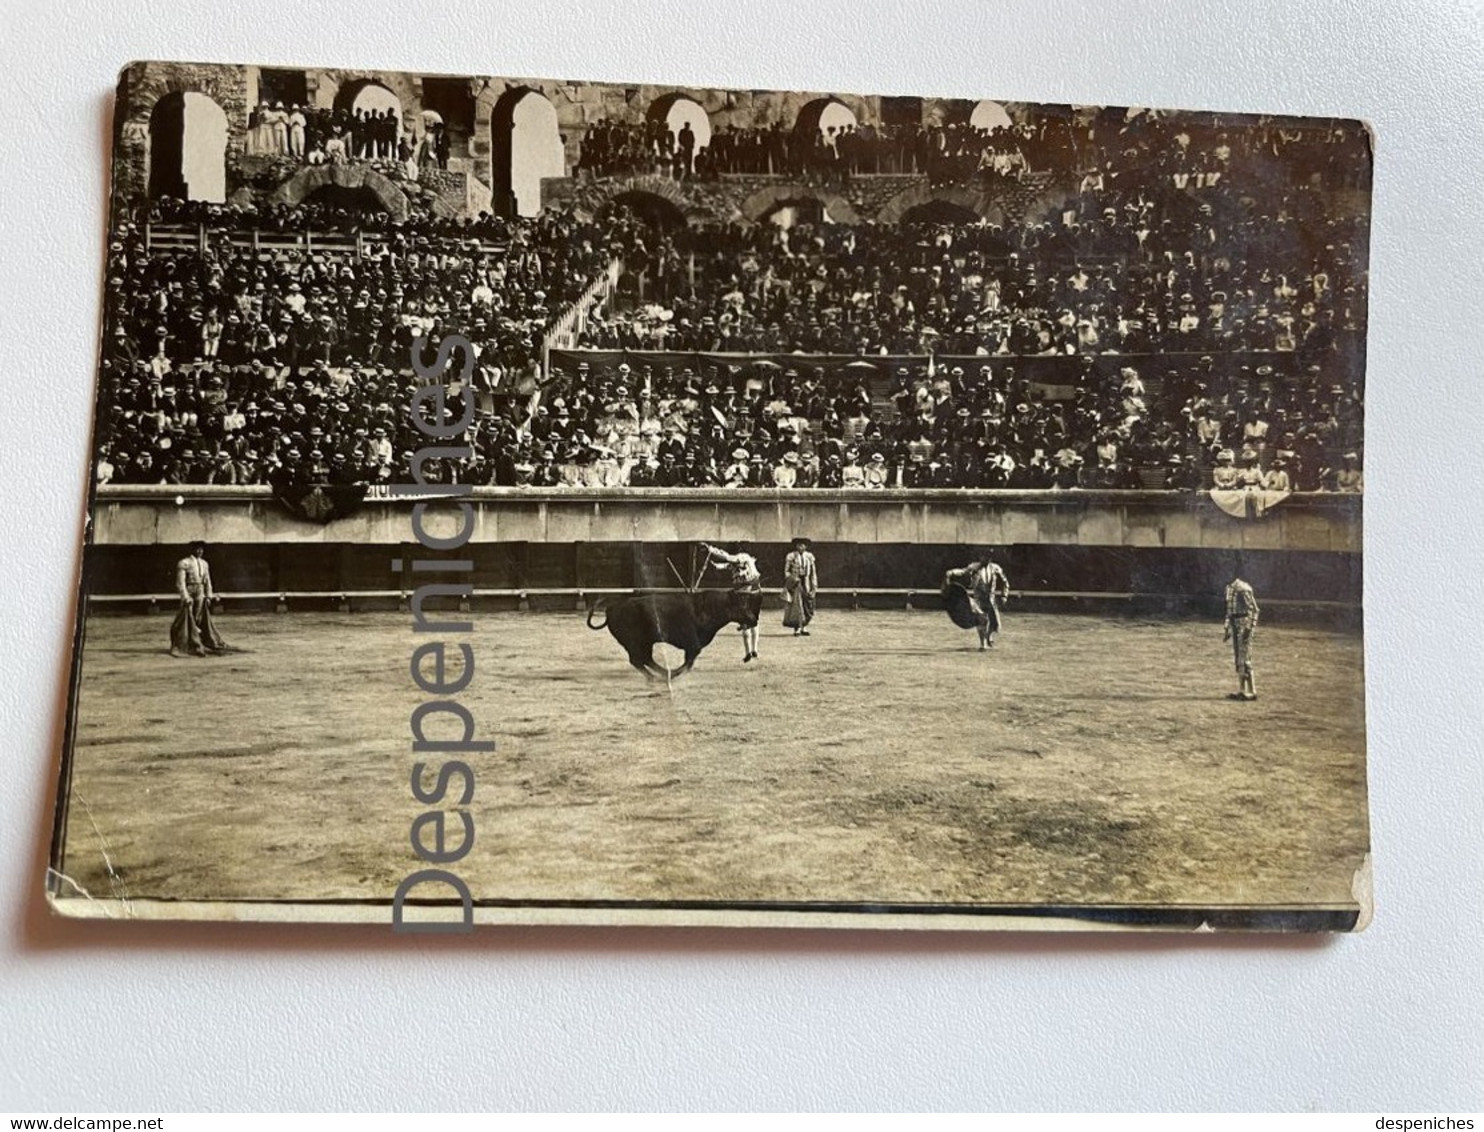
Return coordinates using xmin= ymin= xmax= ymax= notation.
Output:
xmin=98 ymin=103 xmax=1367 ymax=493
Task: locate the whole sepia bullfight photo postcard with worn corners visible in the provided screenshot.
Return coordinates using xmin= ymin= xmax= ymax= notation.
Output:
xmin=46 ymin=62 xmax=1371 ymax=932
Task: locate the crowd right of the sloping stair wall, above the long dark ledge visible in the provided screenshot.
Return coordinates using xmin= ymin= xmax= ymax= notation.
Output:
xmin=582 ymin=187 xmax=1365 ymax=363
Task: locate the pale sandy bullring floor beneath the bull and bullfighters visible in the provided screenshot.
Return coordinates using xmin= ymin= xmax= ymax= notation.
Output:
xmin=61 ymin=602 xmax=1368 ymax=908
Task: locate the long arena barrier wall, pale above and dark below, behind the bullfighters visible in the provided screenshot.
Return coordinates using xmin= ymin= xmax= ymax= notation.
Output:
xmin=85 ymin=485 xmax=1362 ymax=616
